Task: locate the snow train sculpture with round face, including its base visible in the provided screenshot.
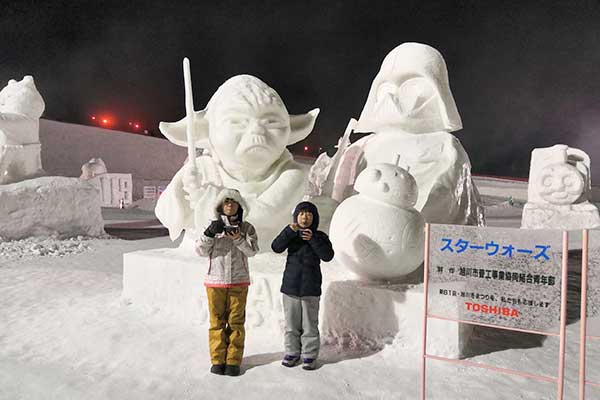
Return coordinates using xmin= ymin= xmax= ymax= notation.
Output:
xmin=521 ymin=144 xmax=600 ymax=230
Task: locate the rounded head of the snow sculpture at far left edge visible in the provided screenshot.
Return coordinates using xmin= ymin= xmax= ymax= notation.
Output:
xmin=0 ymin=75 xmax=45 ymax=119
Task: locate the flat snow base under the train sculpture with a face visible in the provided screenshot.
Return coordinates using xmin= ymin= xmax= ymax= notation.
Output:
xmin=521 ymin=202 xmax=600 ymax=230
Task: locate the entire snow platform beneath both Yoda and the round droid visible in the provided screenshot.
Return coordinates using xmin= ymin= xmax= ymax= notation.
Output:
xmin=122 ymin=248 xmax=471 ymax=357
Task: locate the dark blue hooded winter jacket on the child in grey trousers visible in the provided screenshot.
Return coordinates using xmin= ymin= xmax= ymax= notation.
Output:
xmin=271 ymin=201 xmax=333 ymax=297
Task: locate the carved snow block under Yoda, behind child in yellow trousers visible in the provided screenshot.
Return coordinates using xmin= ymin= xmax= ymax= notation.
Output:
xmin=121 ymin=252 xmax=285 ymax=336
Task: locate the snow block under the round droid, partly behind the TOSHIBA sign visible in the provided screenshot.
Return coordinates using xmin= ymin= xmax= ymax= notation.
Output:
xmin=321 ymin=281 xmax=473 ymax=358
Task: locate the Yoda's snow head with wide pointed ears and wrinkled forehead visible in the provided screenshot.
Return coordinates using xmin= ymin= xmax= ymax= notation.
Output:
xmin=160 ymin=75 xmax=319 ymax=175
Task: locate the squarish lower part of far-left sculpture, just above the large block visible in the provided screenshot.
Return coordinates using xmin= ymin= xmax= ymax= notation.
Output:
xmin=0 ymin=143 xmax=44 ymax=185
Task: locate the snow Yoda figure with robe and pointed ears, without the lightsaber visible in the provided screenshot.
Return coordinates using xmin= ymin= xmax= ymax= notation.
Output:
xmin=156 ymin=75 xmax=319 ymax=248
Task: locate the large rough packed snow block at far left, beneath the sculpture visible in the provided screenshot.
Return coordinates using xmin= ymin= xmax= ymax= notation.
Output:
xmin=0 ymin=177 xmax=104 ymax=240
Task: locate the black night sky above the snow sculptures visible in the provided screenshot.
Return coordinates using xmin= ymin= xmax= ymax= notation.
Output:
xmin=0 ymin=0 xmax=600 ymax=177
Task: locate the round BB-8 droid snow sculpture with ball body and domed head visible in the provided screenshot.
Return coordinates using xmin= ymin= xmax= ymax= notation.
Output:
xmin=329 ymin=163 xmax=425 ymax=281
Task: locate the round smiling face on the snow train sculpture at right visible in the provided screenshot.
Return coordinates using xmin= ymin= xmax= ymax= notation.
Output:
xmin=537 ymin=164 xmax=584 ymax=205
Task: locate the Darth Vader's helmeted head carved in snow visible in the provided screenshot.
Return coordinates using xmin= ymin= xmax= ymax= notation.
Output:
xmin=355 ymin=43 xmax=462 ymax=133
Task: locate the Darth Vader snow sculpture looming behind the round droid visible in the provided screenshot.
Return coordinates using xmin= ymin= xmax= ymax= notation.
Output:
xmin=310 ymin=43 xmax=484 ymax=225
